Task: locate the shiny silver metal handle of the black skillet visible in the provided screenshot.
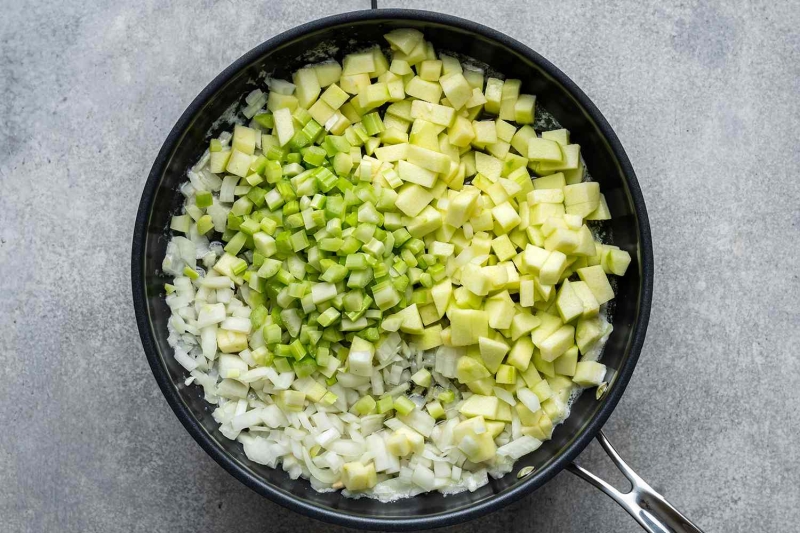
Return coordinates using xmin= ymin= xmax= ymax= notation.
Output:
xmin=567 ymin=431 xmax=703 ymax=533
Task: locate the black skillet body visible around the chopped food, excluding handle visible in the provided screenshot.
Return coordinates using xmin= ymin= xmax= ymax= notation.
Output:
xmin=132 ymin=10 xmax=652 ymax=529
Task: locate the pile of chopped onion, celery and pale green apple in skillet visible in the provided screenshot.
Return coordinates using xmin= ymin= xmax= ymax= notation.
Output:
xmin=163 ymin=29 xmax=631 ymax=500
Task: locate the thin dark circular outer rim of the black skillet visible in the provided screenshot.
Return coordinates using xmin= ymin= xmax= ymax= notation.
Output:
xmin=131 ymin=9 xmax=653 ymax=531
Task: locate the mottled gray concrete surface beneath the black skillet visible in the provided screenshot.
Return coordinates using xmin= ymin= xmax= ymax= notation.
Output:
xmin=0 ymin=0 xmax=800 ymax=533
